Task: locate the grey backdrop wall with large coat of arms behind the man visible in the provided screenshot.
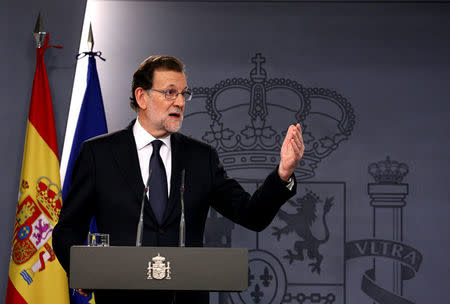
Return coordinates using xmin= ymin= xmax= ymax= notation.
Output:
xmin=0 ymin=1 xmax=450 ymax=303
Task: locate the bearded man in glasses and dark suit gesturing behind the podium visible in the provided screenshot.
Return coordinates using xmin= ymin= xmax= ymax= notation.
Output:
xmin=53 ymin=56 xmax=304 ymax=304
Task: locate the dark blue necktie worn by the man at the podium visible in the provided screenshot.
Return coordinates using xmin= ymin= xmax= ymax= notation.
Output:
xmin=148 ymin=140 xmax=167 ymax=224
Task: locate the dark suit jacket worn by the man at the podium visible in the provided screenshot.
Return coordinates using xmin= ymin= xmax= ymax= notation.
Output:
xmin=53 ymin=123 xmax=295 ymax=303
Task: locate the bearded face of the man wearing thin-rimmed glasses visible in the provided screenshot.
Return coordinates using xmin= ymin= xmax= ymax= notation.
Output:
xmin=138 ymin=70 xmax=187 ymax=138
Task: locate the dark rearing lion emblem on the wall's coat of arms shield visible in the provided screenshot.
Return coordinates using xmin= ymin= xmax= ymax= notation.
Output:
xmin=272 ymin=190 xmax=334 ymax=274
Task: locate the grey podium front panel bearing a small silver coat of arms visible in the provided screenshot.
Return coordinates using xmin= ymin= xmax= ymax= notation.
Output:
xmin=69 ymin=246 xmax=248 ymax=291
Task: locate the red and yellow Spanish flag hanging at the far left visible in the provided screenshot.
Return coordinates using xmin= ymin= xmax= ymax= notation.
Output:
xmin=6 ymin=34 xmax=69 ymax=304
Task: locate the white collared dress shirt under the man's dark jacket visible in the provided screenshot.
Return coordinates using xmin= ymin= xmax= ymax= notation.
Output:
xmin=133 ymin=119 xmax=172 ymax=197
